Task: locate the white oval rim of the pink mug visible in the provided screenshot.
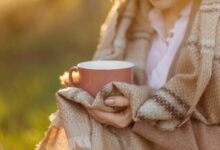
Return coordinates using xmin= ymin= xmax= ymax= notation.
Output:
xmin=77 ymin=60 xmax=135 ymax=70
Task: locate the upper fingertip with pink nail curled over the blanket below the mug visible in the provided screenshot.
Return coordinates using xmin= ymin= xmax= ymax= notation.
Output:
xmin=105 ymin=96 xmax=130 ymax=107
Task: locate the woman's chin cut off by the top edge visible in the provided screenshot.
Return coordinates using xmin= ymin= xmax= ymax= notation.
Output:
xmin=149 ymin=0 xmax=173 ymax=10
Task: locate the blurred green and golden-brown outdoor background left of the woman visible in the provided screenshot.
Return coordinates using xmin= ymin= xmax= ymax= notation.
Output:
xmin=0 ymin=0 xmax=112 ymax=150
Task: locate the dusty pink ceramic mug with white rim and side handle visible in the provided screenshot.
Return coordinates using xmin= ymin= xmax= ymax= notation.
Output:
xmin=69 ymin=60 xmax=134 ymax=97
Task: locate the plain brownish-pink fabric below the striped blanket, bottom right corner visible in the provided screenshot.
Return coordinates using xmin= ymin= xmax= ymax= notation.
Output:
xmin=133 ymin=119 xmax=220 ymax=150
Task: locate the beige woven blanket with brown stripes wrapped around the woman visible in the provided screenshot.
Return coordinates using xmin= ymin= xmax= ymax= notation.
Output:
xmin=37 ymin=0 xmax=220 ymax=150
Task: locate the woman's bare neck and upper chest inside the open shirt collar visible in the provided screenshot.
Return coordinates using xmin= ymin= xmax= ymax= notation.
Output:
xmin=162 ymin=0 xmax=193 ymax=36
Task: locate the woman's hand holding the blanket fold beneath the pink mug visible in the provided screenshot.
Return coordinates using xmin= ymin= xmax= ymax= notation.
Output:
xmin=86 ymin=96 xmax=132 ymax=128
